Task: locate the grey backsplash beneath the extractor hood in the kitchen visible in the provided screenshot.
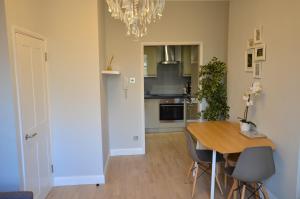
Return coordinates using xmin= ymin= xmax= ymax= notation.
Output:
xmin=144 ymin=64 xmax=191 ymax=94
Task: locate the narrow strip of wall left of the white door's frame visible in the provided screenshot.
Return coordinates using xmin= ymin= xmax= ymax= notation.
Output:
xmin=0 ymin=0 xmax=20 ymax=192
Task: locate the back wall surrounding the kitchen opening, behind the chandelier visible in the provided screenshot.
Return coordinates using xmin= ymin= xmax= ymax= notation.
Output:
xmin=105 ymin=2 xmax=228 ymax=151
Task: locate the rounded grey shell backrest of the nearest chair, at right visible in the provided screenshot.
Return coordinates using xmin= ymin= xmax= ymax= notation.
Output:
xmin=232 ymin=147 xmax=275 ymax=182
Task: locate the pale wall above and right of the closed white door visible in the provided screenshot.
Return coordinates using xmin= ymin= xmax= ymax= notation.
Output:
xmin=6 ymin=0 xmax=103 ymax=184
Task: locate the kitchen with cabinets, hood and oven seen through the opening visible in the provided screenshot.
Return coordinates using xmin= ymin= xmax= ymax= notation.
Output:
xmin=144 ymin=43 xmax=201 ymax=133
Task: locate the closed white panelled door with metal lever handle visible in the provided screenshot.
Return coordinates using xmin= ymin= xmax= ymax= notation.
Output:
xmin=15 ymin=33 xmax=52 ymax=199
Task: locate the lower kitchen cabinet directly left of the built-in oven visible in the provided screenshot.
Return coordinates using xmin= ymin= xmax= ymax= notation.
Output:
xmin=145 ymin=99 xmax=160 ymax=129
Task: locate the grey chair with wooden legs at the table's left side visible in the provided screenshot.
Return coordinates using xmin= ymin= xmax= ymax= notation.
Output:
xmin=184 ymin=132 xmax=224 ymax=198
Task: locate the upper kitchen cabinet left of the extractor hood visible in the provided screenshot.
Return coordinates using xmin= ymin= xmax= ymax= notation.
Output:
xmin=144 ymin=46 xmax=160 ymax=77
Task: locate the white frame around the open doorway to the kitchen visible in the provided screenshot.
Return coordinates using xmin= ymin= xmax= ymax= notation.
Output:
xmin=140 ymin=41 xmax=204 ymax=154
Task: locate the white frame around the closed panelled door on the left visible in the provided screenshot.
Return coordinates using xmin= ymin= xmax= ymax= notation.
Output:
xmin=11 ymin=26 xmax=53 ymax=190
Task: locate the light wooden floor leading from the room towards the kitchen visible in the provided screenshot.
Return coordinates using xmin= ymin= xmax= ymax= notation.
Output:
xmin=47 ymin=133 xmax=225 ymax=199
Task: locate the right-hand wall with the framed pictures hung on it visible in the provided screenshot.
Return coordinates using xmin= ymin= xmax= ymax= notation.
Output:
xmin=228 ymin=0 xmax=300 ymax=199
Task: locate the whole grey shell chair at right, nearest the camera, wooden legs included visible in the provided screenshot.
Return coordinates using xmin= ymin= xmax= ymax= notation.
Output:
xmin=225 ymin=147 xmax=275 ymax=199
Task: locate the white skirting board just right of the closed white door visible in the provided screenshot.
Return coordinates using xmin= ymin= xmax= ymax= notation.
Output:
xmin=54 ymin=175 xmax=105 ymax=186
